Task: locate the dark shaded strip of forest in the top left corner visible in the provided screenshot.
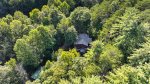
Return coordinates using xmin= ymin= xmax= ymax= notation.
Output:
xmin=0 ymin=0 xmax=48 ymax=18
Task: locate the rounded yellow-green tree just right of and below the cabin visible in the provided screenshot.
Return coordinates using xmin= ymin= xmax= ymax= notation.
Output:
xmin=99 ymin=44 xmax=123 ymax=74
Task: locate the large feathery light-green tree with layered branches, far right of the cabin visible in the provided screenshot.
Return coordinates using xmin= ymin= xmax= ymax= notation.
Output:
xmin=104 ymin=8 xmax=145 ymax=62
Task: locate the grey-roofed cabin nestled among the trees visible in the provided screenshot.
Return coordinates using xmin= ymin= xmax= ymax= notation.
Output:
xmin=74 ymin=34 xmax=92 ymax=53
